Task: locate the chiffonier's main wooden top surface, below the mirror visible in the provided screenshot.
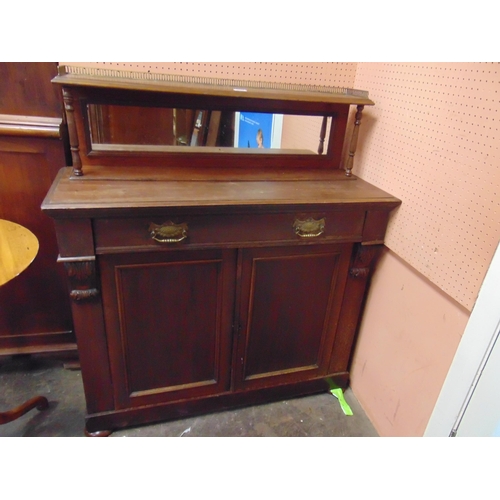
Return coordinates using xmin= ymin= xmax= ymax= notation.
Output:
xmin=42 ymin=167 xmax=400 ymax=217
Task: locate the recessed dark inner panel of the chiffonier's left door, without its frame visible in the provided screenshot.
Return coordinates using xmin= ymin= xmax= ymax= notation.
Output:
xmin=115 ymin=260 xmax=220 ymax=393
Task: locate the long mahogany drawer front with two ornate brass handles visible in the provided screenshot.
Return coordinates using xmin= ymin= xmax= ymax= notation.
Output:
xmin=94 ymin=210 xmax=365 ymax=253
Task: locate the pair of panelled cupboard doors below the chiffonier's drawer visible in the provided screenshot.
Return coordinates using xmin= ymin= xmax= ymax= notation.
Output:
xmin=97 ymin=243 xmax=353 ymax=410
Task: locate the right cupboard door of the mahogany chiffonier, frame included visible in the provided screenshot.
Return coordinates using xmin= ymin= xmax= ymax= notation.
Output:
xmin=234 ymin=244 xmax=352 ymax=389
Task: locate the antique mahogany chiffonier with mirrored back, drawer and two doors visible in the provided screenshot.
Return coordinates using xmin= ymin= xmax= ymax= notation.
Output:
xmin=42 ymin=67 xmax=400 ymax=435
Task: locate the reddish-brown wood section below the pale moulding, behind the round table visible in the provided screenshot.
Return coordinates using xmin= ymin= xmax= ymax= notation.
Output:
xmin=0 ymin=137 xmax=75 ymax=350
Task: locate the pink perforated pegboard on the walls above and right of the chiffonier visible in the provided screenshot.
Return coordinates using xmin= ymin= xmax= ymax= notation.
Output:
xmin=61 ymin=62 xmax=500 ymax=310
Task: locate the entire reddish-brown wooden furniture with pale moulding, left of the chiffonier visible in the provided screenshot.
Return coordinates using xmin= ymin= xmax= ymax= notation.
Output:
xmin=0 ymin=63 xmax=76 ymax=355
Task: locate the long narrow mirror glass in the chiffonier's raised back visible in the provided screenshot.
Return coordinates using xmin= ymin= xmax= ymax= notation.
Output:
xmin=88 ymin=104 xmax=331 ymax=155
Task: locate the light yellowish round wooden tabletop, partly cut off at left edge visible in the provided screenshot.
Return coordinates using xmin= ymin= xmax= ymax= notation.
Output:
xmin=0 ymin=219 xmax=39 ymax=286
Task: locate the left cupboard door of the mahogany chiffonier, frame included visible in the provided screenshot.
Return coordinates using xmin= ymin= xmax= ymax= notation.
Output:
xmin=99 ymin=250 xmax=236 ymax=408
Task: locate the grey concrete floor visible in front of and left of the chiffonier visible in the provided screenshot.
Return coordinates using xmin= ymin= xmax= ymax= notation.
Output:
xmin=0 ymin=357 xmax=377 ymax=437
